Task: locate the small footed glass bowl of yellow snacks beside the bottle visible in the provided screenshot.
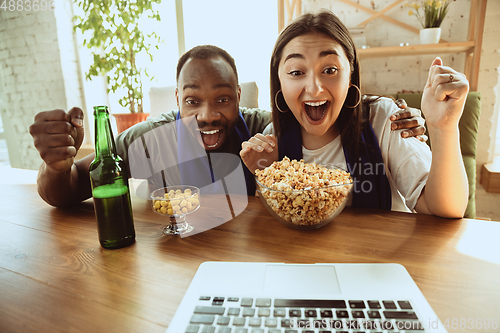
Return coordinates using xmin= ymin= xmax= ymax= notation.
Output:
xmin=151 ymin=185 xmax=200 ymax=235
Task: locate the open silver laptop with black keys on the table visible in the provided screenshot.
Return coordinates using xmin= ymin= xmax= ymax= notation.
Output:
xmin=167 ymin=262 xmax=447 ymax=333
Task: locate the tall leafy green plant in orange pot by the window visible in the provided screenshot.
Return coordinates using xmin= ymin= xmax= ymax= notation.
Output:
xmin=74 ymin=0 xmax=161 ymax=132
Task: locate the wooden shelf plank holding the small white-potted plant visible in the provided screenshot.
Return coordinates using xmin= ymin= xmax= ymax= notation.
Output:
xmin=357 ymin=41 xmax=476 ymax=59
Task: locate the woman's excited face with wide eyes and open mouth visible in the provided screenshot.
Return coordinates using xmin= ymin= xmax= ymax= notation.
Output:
xmin=278 ymin=34 xmax=351 ymax=136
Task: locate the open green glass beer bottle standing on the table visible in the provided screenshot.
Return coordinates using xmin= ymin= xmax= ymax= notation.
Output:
xmin=90 ymin=106 xmax=135 ymax=249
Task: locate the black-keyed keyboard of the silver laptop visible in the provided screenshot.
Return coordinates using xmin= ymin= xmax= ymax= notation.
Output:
xmin=185 ymin=296 xmax=425 ymax=333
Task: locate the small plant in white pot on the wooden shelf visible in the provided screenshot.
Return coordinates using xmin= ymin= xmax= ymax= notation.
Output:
xmin=408 ymin=0 xmax=450 ymax=44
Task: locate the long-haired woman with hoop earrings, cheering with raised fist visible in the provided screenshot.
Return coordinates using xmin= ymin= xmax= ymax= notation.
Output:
xmin=240 ymin=11 xmax=469 ymax=218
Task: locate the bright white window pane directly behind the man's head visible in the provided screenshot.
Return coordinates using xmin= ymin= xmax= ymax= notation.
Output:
xmin=183 ymin=0 xmax=278 ymax=110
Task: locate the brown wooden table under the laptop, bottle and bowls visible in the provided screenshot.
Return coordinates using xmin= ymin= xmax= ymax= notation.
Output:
xmin=0 ymin=184 xmax=500 ymax=333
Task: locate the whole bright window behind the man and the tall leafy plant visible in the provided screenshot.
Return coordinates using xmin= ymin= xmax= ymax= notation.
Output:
xmin=74 ymin=0 xmax=278 ymax=138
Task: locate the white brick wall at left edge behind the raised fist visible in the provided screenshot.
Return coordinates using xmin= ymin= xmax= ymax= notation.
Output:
xmin=0 ymin=0 xmax=81 ymax=169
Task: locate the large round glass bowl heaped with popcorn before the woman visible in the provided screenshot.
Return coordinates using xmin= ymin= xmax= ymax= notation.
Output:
xmin=255 ymin=157 xmax=353 ymax=229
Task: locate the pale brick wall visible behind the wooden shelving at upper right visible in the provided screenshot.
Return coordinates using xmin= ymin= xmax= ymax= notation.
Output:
xmin=302 ymin=0 xmax=470 ymax=94
